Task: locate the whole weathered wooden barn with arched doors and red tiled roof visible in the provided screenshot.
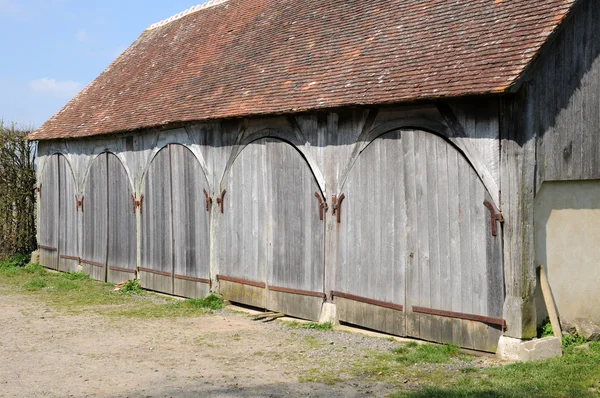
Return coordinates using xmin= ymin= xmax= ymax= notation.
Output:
xmin=29 ymin=0 xmax=600 ymax=351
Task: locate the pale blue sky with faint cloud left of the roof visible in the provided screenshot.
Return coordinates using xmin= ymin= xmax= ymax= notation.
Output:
xmin=0 ymin=0 xmax=204 ymax=128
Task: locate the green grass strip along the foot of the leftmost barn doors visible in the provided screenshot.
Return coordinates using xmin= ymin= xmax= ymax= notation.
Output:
xmin=0 ymin=256 xmax=223 ymax=318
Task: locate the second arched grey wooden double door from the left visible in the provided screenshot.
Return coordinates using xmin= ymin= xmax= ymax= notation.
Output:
xmin=81 ymin=153 xmax=137 ymax=283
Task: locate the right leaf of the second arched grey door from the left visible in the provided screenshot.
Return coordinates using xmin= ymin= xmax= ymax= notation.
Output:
xmin=107 ymin=154 xmax=138 ymax=283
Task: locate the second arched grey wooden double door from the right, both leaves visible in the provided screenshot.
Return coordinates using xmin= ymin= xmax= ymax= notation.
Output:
xmin=218 ymin=138 xmax=325 ymax=319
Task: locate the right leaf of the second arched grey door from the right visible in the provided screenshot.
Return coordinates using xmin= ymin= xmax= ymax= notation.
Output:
xmin=265 ymin=140 xmax=325 ymax=320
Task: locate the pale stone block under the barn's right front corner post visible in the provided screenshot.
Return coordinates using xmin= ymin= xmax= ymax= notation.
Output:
xmin=496 ymin=336 xmax=562 ymax=362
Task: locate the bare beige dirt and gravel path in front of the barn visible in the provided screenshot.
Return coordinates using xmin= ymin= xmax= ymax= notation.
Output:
xmin=0 ymin=287 xmax=412 ymax=397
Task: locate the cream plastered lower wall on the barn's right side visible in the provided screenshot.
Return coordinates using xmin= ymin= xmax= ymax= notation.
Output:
xmin=535 ymin=180 xmax=600 ymax=323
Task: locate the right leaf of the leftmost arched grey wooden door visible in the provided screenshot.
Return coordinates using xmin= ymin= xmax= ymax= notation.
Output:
xmin=58 ymin=156 xmax=81 ymax=272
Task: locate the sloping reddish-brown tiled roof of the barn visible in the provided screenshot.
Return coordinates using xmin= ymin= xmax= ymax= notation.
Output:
xmin=29 ymin=0 xmax=576 ymax=140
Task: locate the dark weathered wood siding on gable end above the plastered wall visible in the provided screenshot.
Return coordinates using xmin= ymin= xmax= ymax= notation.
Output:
xmin=521 ymin=0 xmax=600 ymax=190
